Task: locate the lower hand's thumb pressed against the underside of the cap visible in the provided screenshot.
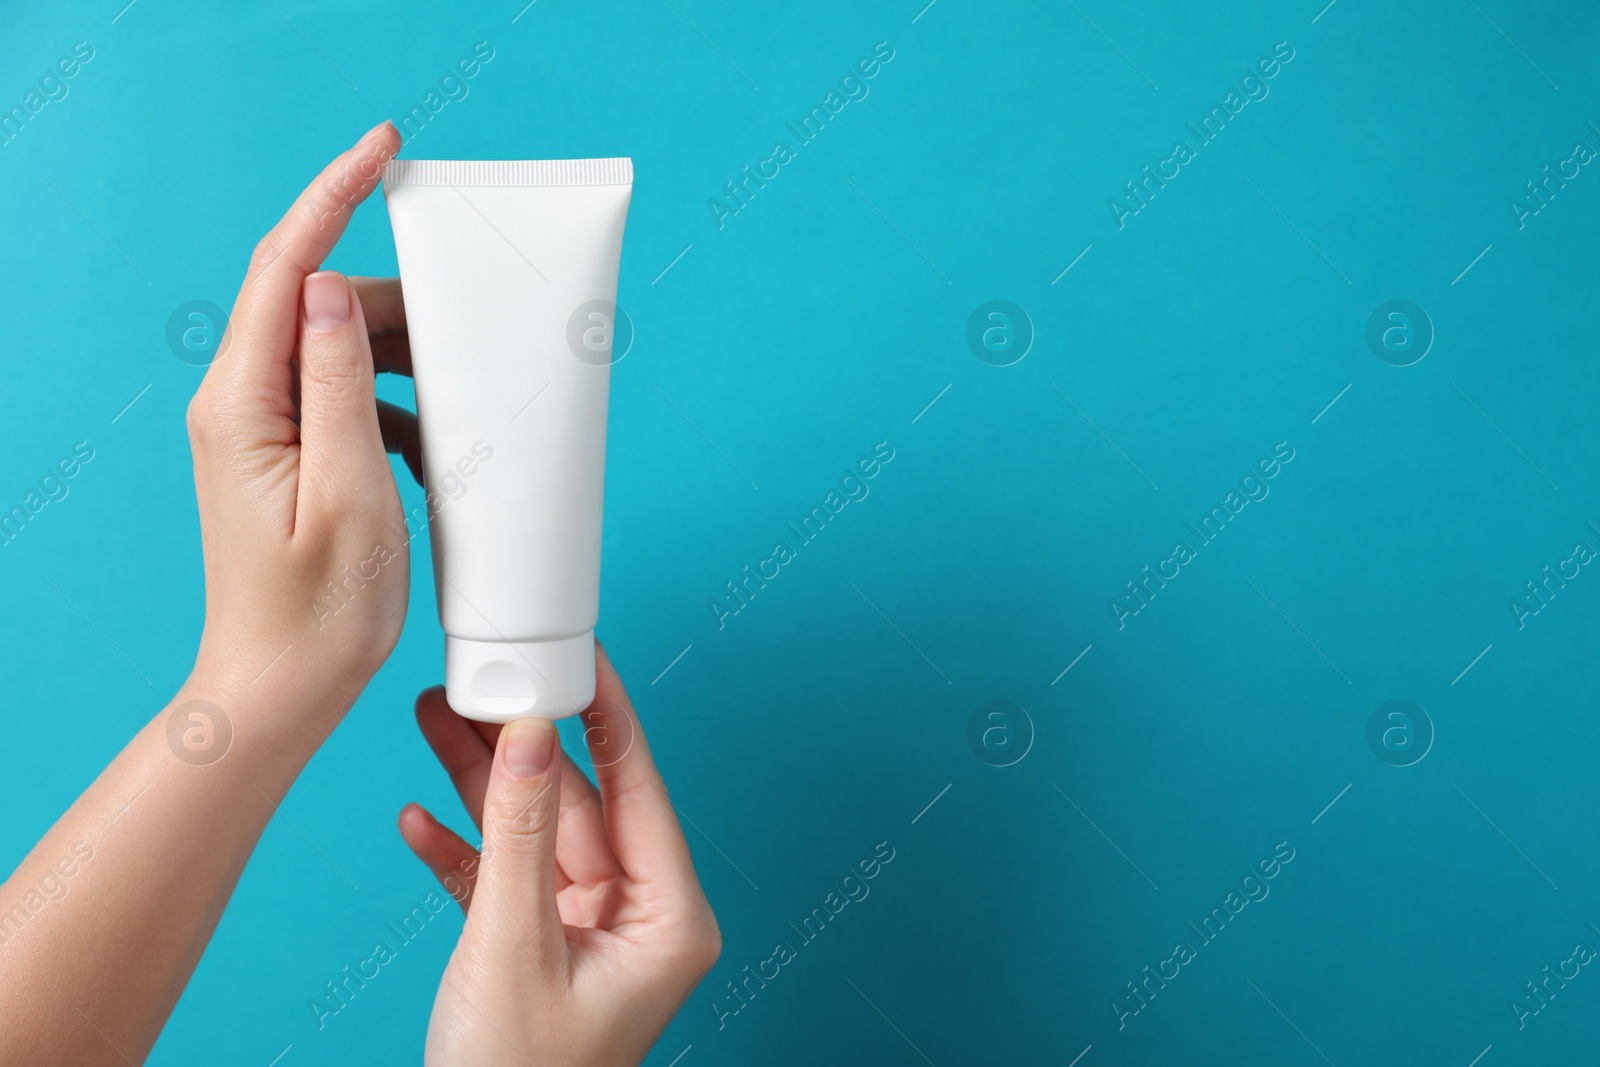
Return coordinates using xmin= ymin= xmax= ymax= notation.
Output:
xmin=467 ymin=718 xmax=566 ymax=973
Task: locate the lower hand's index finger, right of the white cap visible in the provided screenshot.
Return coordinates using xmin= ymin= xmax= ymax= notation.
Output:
xmin=584 ymin=645 xmax=699 ymax=893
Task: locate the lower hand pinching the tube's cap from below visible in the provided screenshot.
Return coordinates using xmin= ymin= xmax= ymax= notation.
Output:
xmin=400 ymin=649 xmax=722 ymax=1067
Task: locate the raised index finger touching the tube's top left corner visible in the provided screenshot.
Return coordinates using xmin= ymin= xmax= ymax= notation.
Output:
xmin=208 ymin=122 xmax=400 ymax=398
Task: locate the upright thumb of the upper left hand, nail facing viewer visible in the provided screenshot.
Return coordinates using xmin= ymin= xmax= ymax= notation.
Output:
xmin=299 ymin=270 xmax=389 ymax=502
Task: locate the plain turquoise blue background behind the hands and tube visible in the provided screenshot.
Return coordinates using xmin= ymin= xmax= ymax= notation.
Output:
xmin=0 ymin=0 xmax=1600 ymax=1067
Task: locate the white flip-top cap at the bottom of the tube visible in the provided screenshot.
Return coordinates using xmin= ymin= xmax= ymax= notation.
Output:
xmin=445 ymin=630 xmax=595 ymax=723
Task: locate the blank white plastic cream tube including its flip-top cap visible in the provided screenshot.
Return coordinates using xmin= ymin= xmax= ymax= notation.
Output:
xmin=384 ymin=158 xmax=634 ymax=723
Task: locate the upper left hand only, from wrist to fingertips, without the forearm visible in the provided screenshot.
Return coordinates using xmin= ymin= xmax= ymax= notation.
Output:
xmin=189 ymin=123 xmax=414 ymax=716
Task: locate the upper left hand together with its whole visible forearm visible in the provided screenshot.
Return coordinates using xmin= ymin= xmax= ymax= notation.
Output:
xmin=0 ymin=123 xmax=416 ymax=1067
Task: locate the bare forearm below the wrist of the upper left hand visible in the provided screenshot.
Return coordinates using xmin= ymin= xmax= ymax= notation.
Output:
xmin=0 ymin=673 xmax=342 ymax=1067
